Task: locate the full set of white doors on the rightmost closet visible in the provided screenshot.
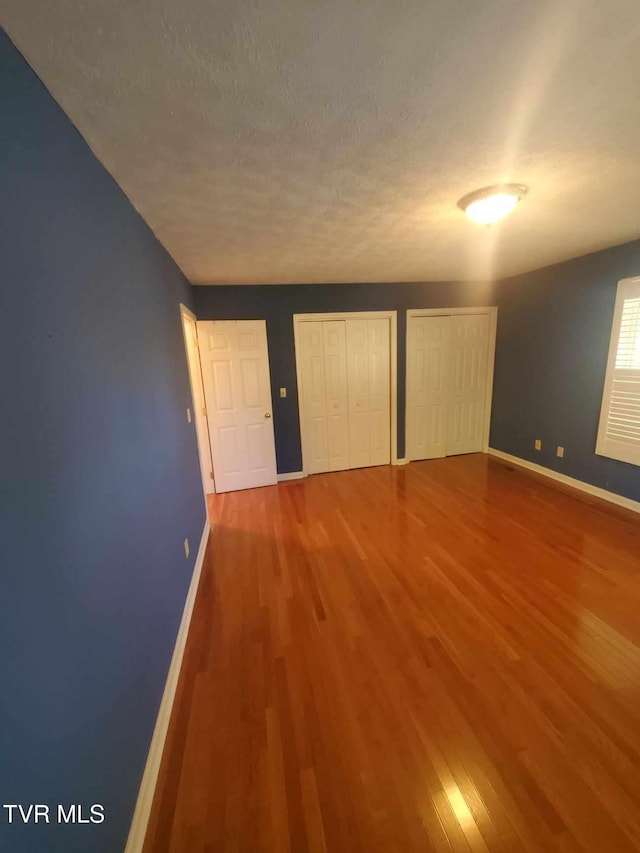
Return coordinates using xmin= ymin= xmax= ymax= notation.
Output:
xmin=407 ymin=313 xmax=492 ymax=460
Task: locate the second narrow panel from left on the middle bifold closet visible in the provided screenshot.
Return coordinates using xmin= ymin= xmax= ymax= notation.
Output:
xmin=321 ymin=320 xmax=350 ymax=471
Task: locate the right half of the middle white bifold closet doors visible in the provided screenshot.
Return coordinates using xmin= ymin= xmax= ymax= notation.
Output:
xmin=346 ymin=318 xmax=391 ymax=468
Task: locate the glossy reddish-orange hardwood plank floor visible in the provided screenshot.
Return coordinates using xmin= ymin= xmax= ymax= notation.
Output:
xmin=145 ymin=455 xmax=640 ymax=853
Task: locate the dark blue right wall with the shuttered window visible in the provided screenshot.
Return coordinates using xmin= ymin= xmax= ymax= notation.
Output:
xmin=491 ymin=241 xmax=640 ymax=501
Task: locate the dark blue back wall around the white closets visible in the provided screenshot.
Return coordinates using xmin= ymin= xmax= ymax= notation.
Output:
xmin=194 ymin=281 xmax=495 ymax=474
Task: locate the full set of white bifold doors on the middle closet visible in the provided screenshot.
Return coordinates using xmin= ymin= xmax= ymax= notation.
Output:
xmin=298 ymin=318 xmax=391 ymax=474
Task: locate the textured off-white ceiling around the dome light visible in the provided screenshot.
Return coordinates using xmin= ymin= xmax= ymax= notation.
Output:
xmin=0 ymin=0 xmax=640 ymax=283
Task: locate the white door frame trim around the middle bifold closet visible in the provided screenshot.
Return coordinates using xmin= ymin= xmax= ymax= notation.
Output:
xmin=293 ymin=311 xmax=398 ymax=477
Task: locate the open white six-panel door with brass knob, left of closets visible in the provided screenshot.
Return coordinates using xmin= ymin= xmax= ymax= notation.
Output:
xmin=198 ymin=320 xmax=278 ymax=492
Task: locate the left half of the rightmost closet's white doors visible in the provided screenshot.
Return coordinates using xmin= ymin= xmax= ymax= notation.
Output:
xmin=407 ymin=317 xmax=450 ymax=459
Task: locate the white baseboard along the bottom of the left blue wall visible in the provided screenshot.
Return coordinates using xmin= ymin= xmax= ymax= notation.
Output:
xmin=125 ymin=521 xmax=211 ymax=853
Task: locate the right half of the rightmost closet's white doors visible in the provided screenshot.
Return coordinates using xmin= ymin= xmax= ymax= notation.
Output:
xmin=446 ymin=314 xmax=489 ymax=456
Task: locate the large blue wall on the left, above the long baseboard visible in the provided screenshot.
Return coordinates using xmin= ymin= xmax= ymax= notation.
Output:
xmin=0 ymin=32 xmax=205 ymax=853
